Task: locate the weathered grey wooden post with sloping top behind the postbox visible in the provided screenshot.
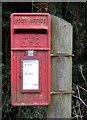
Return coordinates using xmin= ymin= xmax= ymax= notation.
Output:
xmin=46 ymin=16 xmax=72 ymax=118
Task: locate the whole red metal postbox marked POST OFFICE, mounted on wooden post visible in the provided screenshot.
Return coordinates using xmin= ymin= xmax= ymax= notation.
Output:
xmin=11 ymin=13 xmax=50 ymax=106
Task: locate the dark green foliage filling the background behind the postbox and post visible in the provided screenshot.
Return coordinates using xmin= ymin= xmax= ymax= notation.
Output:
xmin=2 ymin=2 xmax=87 ymax=120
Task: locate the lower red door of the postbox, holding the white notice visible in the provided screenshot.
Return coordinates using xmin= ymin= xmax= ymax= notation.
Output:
xmin=12 ymin=51 xmax=50 ymax=105
